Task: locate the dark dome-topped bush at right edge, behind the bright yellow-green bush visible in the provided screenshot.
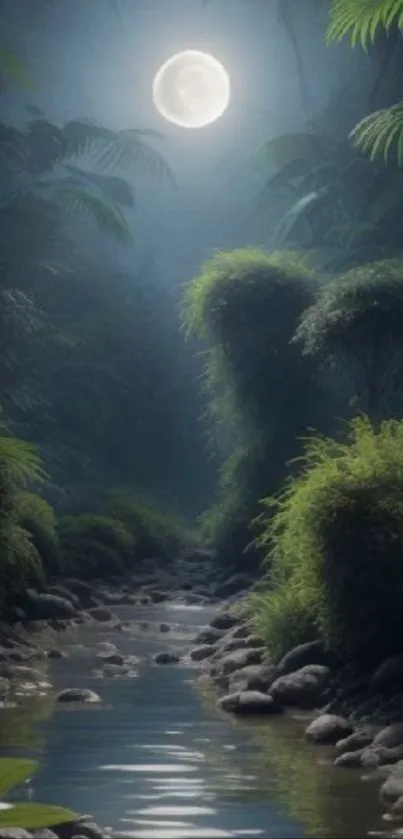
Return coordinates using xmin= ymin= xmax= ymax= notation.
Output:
xmin=296 ymin=259 xmax=403 ymax=421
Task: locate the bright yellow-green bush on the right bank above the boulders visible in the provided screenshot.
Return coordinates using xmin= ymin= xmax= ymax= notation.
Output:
xmin=255 ymin=417 xmax=403 ymax=666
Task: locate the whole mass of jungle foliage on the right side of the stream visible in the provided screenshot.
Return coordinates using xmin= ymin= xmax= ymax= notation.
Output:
xmin=193 ymin=0 xmax=403 ymax=665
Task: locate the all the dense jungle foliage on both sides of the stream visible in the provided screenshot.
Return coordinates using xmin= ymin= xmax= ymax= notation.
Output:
xmin=0 ymin=0 xmax=403 ymax=665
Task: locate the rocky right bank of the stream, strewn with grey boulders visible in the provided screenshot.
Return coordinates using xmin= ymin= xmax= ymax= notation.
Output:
xmin=185 ymin=598 xmax=403 ymax=837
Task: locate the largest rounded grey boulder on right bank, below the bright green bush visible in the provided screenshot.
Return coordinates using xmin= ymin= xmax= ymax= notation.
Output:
xmin=270 ymin=664 xmax=330 ymax=708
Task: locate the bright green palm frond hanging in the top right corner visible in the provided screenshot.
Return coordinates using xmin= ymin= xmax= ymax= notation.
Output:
xmin=326 ymin=0 xmax=403 ymax=49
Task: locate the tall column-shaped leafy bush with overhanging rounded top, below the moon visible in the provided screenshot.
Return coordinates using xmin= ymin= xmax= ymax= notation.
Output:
xmin=183 ymin=248 xmax=326 ymax=566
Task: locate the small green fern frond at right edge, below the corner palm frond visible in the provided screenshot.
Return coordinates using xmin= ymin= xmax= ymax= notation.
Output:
xmin=350 ymin=102 xmax=403 ymax=166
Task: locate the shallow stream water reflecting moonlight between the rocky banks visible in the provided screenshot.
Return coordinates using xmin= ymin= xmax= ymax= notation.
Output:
xmin=0 ymin=605 xmax=388 ymax=839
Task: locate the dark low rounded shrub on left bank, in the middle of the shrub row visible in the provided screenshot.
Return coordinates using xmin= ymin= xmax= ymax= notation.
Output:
xmin=58 ymin=514 xmax=135 ymax=579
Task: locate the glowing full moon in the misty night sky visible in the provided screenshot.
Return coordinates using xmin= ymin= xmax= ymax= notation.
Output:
xmin=153 ymin=50 xmax=230 ymax=128
